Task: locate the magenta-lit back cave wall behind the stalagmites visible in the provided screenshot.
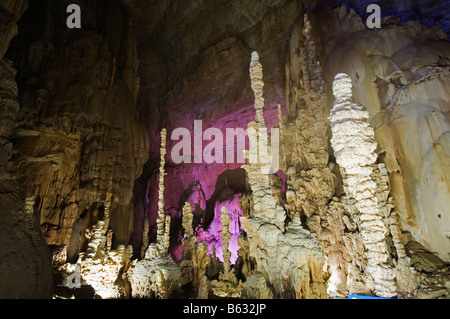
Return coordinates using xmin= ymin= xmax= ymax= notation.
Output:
xmin=130 ymin=103 xmax=286 ymax=264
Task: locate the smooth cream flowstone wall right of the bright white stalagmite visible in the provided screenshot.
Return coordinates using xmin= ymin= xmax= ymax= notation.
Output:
xmin=316 ymin=7 xmax=450 ymax=262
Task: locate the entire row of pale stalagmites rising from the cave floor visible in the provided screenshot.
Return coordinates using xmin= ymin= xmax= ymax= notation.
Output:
xmin=52 ymin=16 xmax=446 ymax=298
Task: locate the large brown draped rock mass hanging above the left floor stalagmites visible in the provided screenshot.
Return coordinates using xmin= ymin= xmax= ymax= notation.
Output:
xmin=9 ymin=1 xmax=148 ymax=284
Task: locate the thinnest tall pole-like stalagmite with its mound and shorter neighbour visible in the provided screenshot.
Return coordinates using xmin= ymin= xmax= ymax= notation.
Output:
xmin=127 ymin=129 xmax=210 ymax=299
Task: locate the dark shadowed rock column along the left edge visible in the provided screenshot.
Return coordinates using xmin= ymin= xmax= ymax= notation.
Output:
xmin=0 ymin=1 xmax=52 ymax=298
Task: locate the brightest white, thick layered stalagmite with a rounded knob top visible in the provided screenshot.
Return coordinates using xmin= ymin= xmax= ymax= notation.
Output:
xmin=329 ymin=73 xmax=397 ymax=297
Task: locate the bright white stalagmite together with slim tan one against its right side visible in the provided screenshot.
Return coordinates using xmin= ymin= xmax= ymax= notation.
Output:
xmin=330 ymin=73 xmax=420 ymax=297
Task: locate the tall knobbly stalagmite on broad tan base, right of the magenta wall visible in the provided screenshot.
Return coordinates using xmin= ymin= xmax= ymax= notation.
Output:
xmin=241 ymin=50 xmax=327 ymax=298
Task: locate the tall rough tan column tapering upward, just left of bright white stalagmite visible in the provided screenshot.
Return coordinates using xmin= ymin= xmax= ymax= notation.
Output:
xmin=281 ymin=15 xmax=350 ymax=296
